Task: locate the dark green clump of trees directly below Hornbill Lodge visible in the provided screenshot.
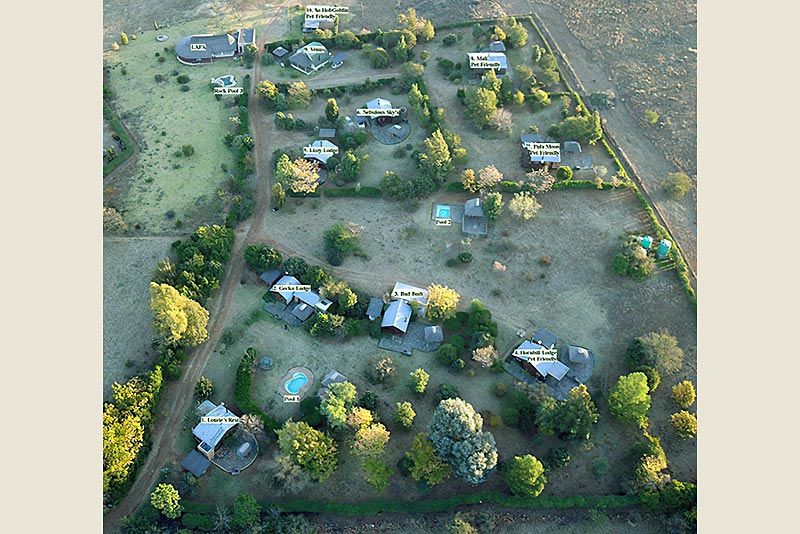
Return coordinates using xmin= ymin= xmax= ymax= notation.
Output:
xmin=502 ymin=384 xmax=599 ymax=440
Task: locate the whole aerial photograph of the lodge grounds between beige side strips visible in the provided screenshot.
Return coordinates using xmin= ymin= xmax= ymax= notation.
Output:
xmin=103 ymin=0 xmax=703 ymax=534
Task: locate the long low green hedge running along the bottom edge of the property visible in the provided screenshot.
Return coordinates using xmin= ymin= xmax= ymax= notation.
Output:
xmin=181 ymin=491 xmax=639 ymax=516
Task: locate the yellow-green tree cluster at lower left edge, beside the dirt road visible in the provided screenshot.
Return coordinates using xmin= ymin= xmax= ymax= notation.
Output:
xmin=103 ymin=366 xmax=163 ymax=501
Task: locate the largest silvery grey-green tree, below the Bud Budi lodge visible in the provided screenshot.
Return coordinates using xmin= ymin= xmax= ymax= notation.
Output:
xmin=428 ymin=398 xmax=497 ymax=484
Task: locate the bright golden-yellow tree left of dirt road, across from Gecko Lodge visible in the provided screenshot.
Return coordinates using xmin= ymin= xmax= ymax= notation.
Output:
xmin=150 ymin=282 xmax=208 ymax=347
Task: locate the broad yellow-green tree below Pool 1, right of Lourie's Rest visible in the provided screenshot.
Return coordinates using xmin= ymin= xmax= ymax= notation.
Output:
xmin=276 ymin=419 xmax=339 ymax=482
